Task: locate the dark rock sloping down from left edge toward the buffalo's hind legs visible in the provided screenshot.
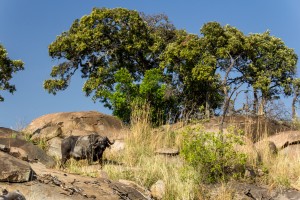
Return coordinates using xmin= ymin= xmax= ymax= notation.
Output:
xmin=0 ymin=138 xmax=56 ymax=167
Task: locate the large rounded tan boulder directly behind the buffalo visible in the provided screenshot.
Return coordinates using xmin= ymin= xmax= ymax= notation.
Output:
xmin=24 ymin=111 xmax=123 ymax=139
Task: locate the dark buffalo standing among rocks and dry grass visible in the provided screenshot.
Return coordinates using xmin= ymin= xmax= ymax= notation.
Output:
xmin=61 ymin=134 xmax=114 ymax=167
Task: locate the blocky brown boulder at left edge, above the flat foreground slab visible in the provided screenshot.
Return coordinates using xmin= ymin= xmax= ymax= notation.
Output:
xmin=0 ymin=151 xmax=33 ymax=182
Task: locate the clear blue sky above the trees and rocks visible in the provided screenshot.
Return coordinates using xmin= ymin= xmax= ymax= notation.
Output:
xmin=0 ymin=0 xmax=300 ymax=129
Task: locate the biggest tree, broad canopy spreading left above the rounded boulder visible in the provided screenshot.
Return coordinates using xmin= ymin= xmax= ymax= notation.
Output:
xmin=44 ymin=8 xmax=177 ymax=122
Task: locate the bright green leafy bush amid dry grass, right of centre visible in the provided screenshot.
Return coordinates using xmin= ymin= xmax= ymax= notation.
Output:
xmin=181 ymin=129 xmax=246 ymax=183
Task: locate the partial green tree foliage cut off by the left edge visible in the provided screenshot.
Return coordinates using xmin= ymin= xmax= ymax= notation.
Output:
xmin=0 ymin=44 xmax=24 ymax=101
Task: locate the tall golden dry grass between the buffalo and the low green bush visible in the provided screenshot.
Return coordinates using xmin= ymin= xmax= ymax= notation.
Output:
xmin=104 ymin=104 xmax=199 ymax=200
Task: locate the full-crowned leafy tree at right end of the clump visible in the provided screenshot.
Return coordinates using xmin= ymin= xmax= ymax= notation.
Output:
xmin=241 ymin=31 xmax=298 ymax=115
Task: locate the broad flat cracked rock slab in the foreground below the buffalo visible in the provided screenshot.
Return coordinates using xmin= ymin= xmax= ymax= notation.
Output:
xmin=0 ymin=163 xmax=147 ymax=200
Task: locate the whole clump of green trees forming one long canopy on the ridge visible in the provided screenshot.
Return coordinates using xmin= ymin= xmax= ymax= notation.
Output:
xmin=44 ymin=8 xmax=297 ymax=124
